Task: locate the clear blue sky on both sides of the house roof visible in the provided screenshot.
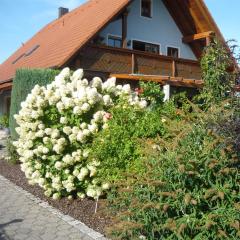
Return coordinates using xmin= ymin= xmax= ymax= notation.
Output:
xmin=0 ymin=0 xmax=240 ymax=63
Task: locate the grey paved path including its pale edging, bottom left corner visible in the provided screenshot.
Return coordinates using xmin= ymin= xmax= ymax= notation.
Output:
xmin=0 ymin=175 xmax=104 ymax=240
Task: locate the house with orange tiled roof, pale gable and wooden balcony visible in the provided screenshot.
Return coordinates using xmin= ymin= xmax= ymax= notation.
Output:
xmin=0 ymin=0 xmax=232 ymax=113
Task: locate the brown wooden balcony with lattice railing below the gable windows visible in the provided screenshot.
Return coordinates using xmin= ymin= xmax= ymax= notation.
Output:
xmin=72 ymin=45 xmax=202 ymax=87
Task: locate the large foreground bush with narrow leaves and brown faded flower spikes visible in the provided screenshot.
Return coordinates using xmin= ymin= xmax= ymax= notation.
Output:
xmin=106 ymin=105 xmax=240 ymax=240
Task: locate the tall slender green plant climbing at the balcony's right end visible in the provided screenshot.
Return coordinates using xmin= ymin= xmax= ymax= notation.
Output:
xmin=201 ymin=39 xmax=234 ymax=105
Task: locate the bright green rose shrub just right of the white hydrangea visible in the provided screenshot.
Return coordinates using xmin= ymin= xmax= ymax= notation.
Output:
xmin=91 ymin=83 xmax=166 ymax=182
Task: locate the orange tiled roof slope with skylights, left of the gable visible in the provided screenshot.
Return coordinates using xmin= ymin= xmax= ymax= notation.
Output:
xmin=0 ymin=0 xmax=130 ymax=83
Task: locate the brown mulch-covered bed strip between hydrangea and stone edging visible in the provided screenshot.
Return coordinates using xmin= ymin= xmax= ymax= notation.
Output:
xmin=0 ymin=160 xmax=110 ymax=233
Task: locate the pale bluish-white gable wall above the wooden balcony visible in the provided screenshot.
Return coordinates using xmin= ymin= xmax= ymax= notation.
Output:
xmin=100 ymin=0 xmax=196 ymax=60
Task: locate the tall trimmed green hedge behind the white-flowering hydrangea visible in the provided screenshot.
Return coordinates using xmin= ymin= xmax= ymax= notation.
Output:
xmin=9 ymin=69 xmax=59 ymax=139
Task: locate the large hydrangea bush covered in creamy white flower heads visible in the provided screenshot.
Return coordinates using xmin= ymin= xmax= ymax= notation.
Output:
xmin=14 ymin=68 xmax=147 ymax=199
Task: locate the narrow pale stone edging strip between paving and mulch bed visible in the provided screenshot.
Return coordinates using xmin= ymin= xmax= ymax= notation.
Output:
xmin=0 ymin=175 xmax=107 ymax=240
